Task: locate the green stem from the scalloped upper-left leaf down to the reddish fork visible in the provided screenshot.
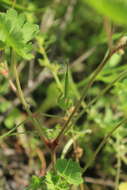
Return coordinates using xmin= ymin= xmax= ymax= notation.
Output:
xmin=11 ymin=50 xmax=45 ymax=146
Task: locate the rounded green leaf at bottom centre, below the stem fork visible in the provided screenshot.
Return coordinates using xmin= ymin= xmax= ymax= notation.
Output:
xmin=55 ymin=159 xmax=83 ymax=185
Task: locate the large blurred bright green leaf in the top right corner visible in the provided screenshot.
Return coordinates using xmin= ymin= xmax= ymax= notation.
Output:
xmin=84 ymin=0 xmax=127 ymax=25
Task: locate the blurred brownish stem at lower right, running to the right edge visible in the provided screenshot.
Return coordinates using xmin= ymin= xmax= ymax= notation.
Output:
xmin=83 ymin=118 xmax=127 ymax=173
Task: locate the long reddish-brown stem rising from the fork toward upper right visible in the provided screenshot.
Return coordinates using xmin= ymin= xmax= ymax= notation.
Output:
xmin=56 ymin=45 xmax=125 ymax=141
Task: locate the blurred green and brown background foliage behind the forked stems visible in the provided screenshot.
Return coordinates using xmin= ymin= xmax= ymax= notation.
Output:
xmin=0 ymin=0 xmax=127 ymax=190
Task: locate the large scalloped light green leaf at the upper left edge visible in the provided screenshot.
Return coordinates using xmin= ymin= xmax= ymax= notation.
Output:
xmin=0 ymin=9 xmax=39 ymax=59
